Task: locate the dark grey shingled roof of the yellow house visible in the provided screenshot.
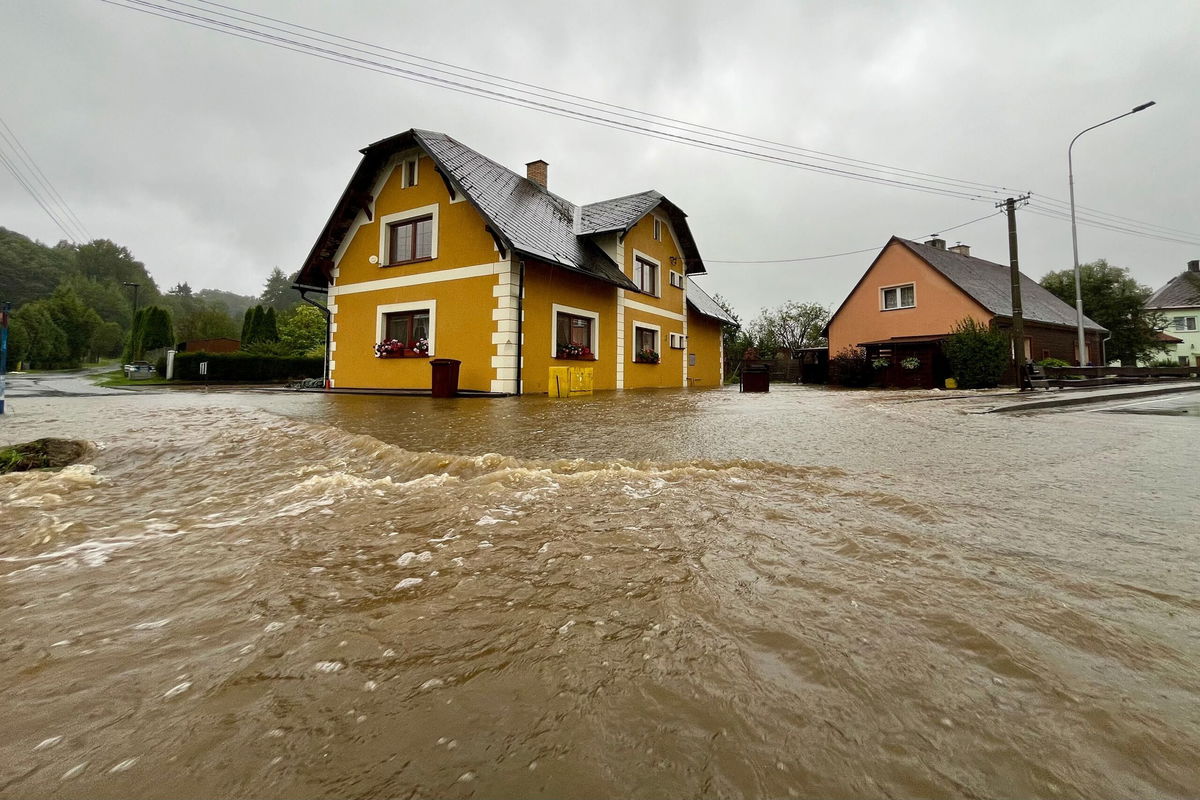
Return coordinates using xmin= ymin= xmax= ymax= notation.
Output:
xmin=299 ymin=128 xmax=704 ymax=289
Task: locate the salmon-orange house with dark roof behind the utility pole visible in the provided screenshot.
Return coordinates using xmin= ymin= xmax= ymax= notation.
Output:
xmin=826 ymin=236 xmax=1108 ymax=387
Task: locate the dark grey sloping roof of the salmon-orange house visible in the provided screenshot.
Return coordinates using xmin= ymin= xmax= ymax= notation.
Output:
xmin=888 ymin=236 xmax=1106 ymax=331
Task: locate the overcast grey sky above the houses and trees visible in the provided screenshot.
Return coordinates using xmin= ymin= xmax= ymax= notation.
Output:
xmin=0 ymin=0 xmax=1200 ymax=320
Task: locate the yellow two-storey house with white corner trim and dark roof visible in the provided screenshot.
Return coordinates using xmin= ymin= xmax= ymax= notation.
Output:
xmin=298 ymin=130 xmax=733 ymax=395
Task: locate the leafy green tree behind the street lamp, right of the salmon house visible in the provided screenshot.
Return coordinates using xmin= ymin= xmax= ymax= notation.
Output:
xmin=1042 ymin=259 xmax=1166 ymax=366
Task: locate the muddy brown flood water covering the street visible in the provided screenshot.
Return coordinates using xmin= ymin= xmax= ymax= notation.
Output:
xmin=0 ymin=387 xmax=1200 ymax=798
